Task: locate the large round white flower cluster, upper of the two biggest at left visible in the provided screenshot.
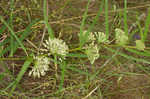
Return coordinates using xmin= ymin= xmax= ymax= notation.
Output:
xmin=43 ymin=38 xmax=69 ymax=56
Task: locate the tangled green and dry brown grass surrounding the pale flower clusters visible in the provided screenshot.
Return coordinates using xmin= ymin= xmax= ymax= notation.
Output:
xmin=0 ymin=0 xmax=150 ymax=99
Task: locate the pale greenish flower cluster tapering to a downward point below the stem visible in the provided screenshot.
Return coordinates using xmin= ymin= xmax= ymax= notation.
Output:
xmin=84 ymin=42 xmax=99 ymax=64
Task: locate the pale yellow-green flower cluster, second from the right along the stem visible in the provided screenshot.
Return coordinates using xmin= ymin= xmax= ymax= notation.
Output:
xmin=115 ymin=28 xmax=128 ymax=45
